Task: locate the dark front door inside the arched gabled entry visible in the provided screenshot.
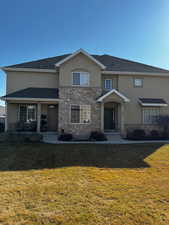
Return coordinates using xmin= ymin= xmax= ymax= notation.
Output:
xmin=104 ymin=108 xmax=116 ymax=130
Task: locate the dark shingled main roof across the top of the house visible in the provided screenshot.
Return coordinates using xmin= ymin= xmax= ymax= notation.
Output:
xmin=3 ymin=50 xmax=169 ymax=74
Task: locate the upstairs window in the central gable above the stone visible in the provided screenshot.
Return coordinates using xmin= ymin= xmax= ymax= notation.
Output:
xmin=72 ymin=72 xmax=89 ymax=86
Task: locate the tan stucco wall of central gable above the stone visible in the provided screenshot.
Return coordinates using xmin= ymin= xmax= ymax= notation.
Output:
xmin=59 ymin=53 xmax=101 ymax=87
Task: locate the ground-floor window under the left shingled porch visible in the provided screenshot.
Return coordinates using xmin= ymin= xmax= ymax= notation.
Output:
xmin=19 ymin=105 xmax=36 ymax=122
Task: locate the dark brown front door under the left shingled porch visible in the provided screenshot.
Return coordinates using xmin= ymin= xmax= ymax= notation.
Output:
xmin=47 ymin=105 xmax=58 ymax=131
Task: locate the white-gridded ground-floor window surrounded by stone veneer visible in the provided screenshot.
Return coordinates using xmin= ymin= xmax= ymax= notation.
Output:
xmin=71 ymin=105 xmax=91 ymax=123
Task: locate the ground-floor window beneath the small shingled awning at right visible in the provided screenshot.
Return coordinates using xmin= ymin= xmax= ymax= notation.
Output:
xmin=143 ymin=108 xmax=160 ymax=124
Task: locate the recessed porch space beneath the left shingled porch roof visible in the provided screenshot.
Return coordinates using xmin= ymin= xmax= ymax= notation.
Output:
xmin=5 ymin=102 xmax=58 ymax=133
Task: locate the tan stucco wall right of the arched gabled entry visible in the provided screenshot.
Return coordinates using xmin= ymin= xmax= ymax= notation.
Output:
xmin=118 ymin=75 xmax=169 ymax=124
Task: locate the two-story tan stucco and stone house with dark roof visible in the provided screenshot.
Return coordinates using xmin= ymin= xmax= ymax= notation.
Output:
xmin=2 ymin=49 xmax=169 ymax=136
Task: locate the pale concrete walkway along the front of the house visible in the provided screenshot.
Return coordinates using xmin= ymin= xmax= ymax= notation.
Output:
xmin=43 ymin=133 xmax=169 ymax=144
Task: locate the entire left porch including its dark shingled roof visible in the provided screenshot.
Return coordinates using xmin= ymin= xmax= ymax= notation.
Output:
xmin=2 ymin=88 xmax=59 ymax=133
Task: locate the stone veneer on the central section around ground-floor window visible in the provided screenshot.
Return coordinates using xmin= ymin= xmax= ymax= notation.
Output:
xmin=58 ymin=87 xmax=102 ymax=137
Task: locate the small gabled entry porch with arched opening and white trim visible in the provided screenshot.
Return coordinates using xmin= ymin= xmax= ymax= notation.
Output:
xmin=97 ymin=89 xmax=130 ymax=134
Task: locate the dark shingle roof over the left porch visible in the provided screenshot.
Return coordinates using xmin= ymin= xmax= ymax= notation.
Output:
xmin=4 ymin=88 xmax=59 ymax=99
